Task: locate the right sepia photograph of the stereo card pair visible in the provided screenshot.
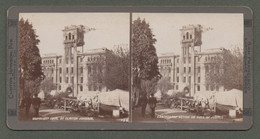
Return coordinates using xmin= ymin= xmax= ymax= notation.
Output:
xmin=131 ymin=13 xmax=244 ymax=123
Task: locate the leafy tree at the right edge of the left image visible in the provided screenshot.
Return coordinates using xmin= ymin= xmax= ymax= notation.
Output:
xmin=89 ymin=45 xmax=130 ymax=90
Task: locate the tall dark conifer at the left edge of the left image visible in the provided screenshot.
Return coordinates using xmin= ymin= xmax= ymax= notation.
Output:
xmin=19 ymin=19 xmax=44 ymax=97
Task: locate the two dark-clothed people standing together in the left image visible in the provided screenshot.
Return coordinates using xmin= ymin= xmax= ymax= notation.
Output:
xmin=22 ymin=94 xmax=41 ymax=117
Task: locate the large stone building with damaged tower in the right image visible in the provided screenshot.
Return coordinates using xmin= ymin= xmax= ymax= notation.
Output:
xmin=158 ymin=25 xmax=225 ymax=96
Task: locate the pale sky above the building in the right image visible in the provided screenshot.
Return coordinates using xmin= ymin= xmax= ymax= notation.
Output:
xmin=133 ymin=13 xmax=244 ymax=55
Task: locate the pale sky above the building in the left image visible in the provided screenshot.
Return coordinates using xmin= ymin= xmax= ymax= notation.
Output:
xmin=19 ymin=13 xmax=130 ymax=55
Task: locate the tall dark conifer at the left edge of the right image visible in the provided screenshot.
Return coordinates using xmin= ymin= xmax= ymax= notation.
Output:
xmin=131 ymin=18 xmax=160 ymax=103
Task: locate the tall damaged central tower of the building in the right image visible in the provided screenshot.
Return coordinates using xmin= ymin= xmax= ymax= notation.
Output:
xmin=180 ymin=25 xmax=202 ymax=96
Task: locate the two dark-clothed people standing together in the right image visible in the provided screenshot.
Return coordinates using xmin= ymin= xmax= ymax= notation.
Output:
xmin=139 ymin=93 xmax=157 ymax=118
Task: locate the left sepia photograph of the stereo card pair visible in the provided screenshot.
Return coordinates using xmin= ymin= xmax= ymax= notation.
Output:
xmin=18 ymin=13 xmax=130 ymax=122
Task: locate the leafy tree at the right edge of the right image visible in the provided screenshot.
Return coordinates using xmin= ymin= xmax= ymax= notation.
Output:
xmin=206 ymin=47 xmax=243 ymax=90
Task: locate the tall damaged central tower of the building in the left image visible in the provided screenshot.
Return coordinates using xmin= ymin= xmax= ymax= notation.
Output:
xmin=62 ymin=25 xmax=85 ymax=97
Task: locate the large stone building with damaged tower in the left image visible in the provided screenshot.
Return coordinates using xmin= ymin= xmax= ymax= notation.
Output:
xmin=42 ymin=26 xmax=110 ymax=96
